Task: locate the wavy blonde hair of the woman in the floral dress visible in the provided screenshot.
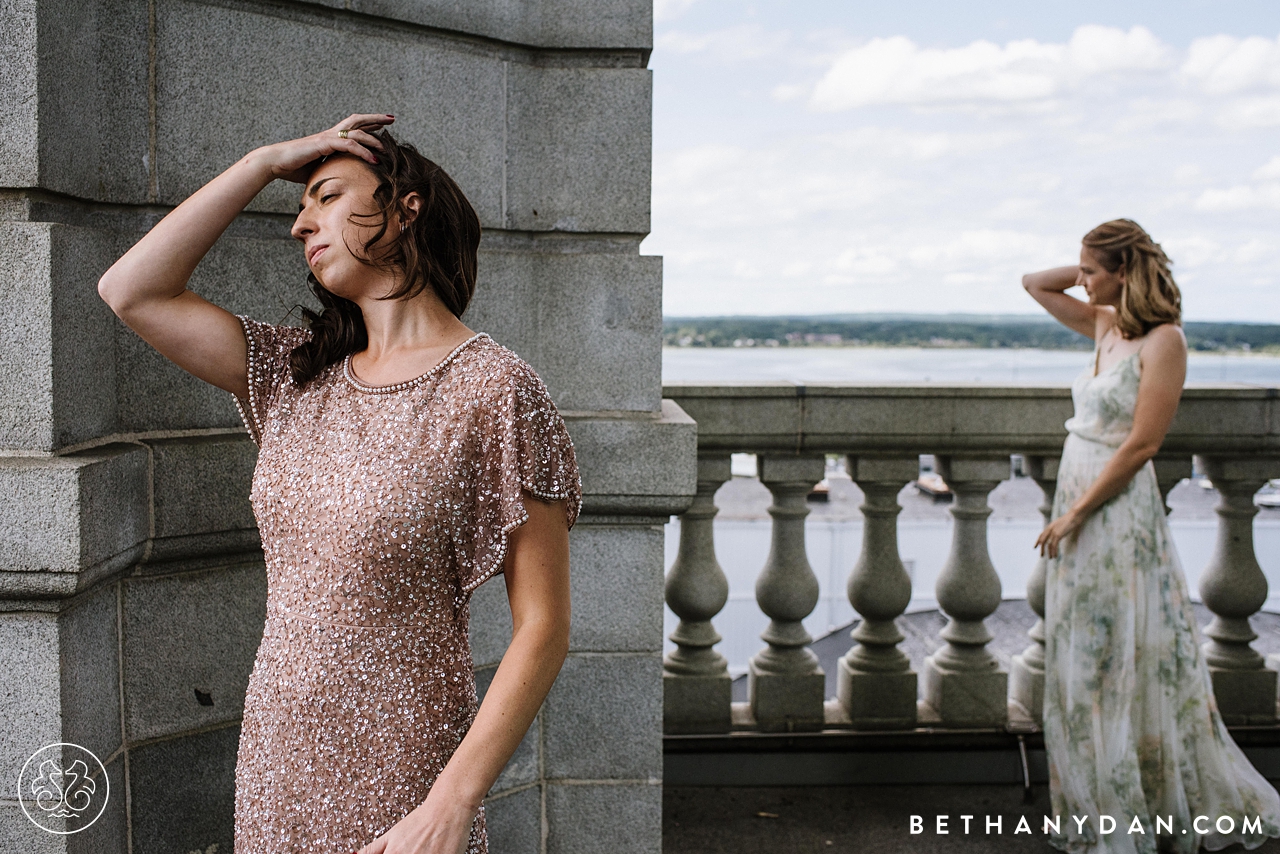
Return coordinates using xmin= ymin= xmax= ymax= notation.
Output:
xmin=1083 ymin=219 xmax=1183 ymax=338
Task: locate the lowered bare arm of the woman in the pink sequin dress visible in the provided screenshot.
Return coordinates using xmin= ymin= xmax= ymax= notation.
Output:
xmin=371 ymin=494 xmax=570 ymax=854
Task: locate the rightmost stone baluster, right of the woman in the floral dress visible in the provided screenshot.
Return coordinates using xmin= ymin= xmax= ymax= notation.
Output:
xmin=1197 ymin=457 xmax=1280 ymax=725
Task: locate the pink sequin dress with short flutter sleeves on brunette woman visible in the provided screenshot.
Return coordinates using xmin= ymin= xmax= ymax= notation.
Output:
xmin=236 ymin=318 xmax=581 ymax=854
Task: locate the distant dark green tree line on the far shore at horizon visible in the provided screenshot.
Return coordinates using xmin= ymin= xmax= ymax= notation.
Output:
xmin=662 ymin=315 xmax=1280 ymax=353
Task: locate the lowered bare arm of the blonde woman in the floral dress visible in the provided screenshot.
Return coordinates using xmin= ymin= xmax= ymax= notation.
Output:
xmin=1036 ymin=324 xmax=1187 ymax=557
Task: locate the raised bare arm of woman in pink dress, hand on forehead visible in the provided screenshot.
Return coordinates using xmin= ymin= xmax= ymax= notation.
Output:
xmin=97 ymin=115 xmax=394 ymax=397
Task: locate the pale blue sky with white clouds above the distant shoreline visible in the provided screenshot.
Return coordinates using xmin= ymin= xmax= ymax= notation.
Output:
xmin=641 ymin=0 xmax=1280 ymax=323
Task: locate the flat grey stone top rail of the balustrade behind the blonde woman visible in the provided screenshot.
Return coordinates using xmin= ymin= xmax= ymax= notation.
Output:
xmin=663 ymin=382 xmax=1280 ymax=456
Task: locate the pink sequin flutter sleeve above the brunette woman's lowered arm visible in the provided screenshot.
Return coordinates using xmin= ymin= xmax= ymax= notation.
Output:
xmin=458 ymin=360 xmax=582 ymax=593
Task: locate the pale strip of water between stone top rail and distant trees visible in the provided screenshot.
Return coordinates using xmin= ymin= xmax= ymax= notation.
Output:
xmin=662 ymin=347 xmax=1280 ymax=387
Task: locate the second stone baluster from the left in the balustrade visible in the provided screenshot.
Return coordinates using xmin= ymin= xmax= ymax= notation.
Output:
xmin=748 ymin=455 xmax=827 ymax=731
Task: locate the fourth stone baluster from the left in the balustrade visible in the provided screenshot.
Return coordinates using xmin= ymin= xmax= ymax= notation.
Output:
xmin=923 ymin=456 xmax=1009 ymax=726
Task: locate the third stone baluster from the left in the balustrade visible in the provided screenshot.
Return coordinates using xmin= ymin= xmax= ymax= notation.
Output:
xmin=836 ymin=456 xmax=920 ymax=730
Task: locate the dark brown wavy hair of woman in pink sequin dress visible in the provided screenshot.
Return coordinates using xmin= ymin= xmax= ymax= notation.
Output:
xmin=289 ymin=128 xmax=480 ymax=385
